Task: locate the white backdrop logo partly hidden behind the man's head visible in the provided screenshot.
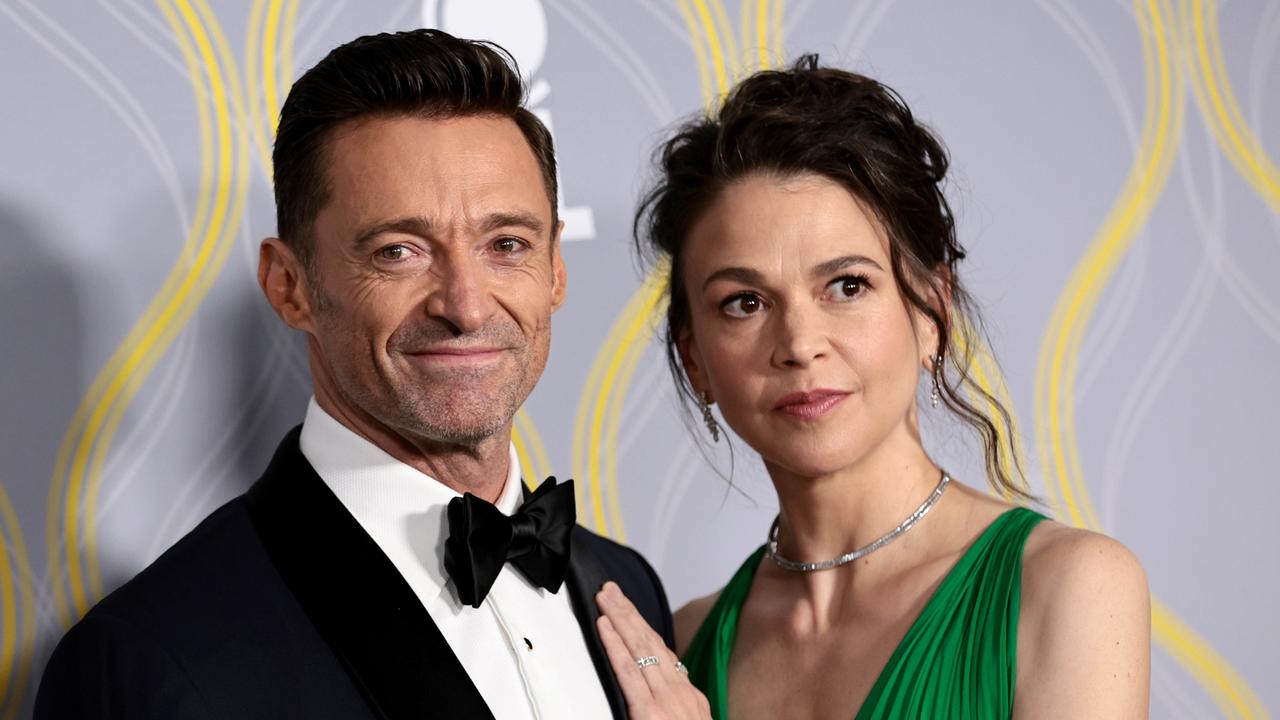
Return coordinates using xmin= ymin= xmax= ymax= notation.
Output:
xmin=422 ymin=0 xmax=595 ymax=241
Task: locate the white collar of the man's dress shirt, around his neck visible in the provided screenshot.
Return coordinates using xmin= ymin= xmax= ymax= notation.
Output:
xmin=300 ymin=397 xmax=524 ymax=602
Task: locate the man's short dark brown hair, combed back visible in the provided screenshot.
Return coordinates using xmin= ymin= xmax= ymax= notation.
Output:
xmin=271 ymin=29 xmax=558 ymax=270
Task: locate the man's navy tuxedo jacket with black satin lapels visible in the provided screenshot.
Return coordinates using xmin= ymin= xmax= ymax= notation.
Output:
xmin=35 ymin=428 xmax=673 ymax=720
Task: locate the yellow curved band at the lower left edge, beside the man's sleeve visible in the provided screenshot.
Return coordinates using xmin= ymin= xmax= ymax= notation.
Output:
xmin=0 ymin=483 xmax=36 ymax=720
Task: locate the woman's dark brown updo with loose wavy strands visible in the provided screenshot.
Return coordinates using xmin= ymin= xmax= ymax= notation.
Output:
xmin=634 ymin=55 xmax=1029 ymax=498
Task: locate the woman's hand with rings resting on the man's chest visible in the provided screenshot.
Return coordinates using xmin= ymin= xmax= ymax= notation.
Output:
xmin=595 ymin=583 xmax=712 ymax=720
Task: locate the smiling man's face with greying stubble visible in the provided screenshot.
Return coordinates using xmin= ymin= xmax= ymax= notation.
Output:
xmin=303 ymin=117 xmax=564 ymax=446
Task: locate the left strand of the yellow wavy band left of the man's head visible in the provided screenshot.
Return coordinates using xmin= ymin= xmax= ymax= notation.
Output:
xmin=45 ymin=0 xmax=212 ymax=629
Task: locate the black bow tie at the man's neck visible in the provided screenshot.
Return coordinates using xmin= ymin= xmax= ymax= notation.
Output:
xmin=444 ymin=478 xmax=577 ymax=607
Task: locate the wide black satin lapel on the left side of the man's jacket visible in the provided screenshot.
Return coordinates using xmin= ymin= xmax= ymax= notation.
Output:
xmin=247 ymin=428 xmax=493 ymax=720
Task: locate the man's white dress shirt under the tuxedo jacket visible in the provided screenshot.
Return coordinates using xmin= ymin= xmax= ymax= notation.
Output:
xmin=301 ymin=398 xmax=612 ymax=720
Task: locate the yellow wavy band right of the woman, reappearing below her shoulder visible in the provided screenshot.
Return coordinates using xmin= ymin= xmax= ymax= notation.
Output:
xmin=1037 ymin=0 xmax=1266 ymax=717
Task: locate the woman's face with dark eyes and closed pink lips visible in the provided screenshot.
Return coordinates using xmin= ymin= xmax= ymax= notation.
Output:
xmin=680 ymin=174 xmax=937 ymax=477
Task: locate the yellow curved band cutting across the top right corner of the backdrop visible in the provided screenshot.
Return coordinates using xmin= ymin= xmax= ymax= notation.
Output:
xmin=1183 ymin=0 xmax=1280 ymax=211
